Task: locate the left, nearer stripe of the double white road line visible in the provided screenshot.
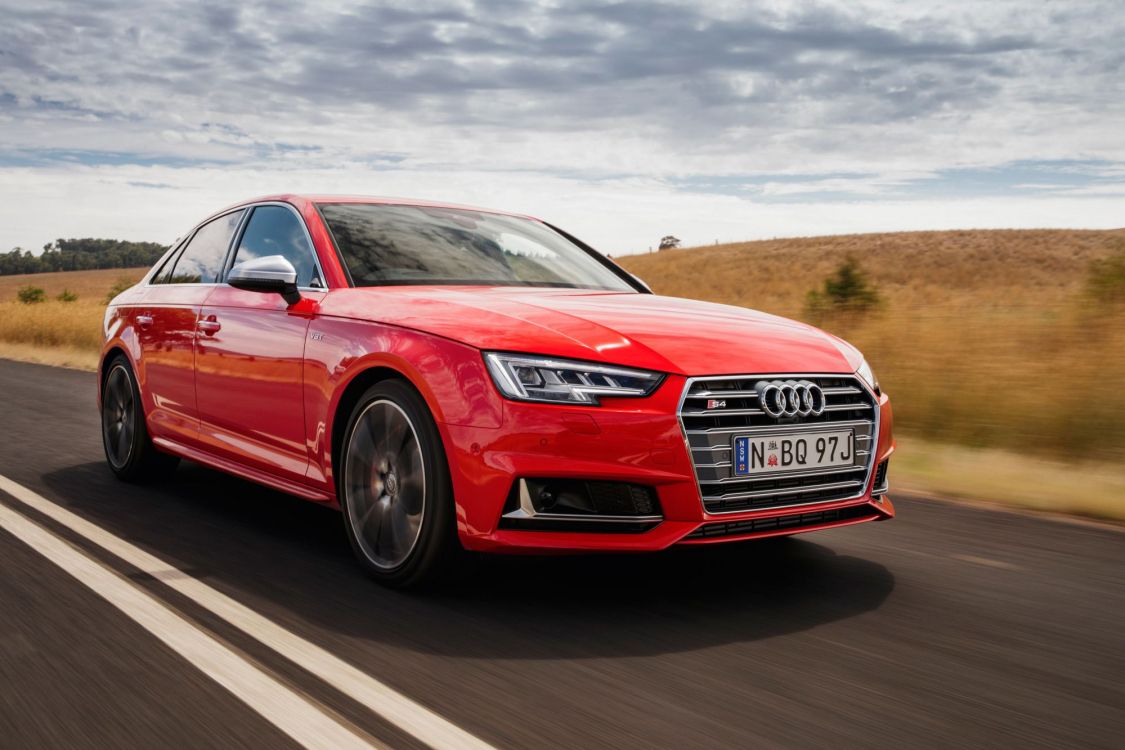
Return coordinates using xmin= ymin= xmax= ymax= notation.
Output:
xmin=0 ymin=504 xmax=376 ymax=750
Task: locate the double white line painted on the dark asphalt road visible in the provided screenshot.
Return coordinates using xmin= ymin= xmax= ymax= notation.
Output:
xmin=0 ymin=476 xmax=491 ymax=750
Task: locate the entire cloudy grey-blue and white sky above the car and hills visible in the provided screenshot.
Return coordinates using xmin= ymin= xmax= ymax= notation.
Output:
xmin=0 ymin=0 xmax=1125 ymax=254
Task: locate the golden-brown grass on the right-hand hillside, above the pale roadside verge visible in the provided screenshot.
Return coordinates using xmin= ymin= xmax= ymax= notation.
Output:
xmin=619 ymin=231 xmax=1125 ymax=462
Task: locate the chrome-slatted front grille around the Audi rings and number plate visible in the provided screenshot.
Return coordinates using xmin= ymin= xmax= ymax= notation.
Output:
xmin=680 ymin=374 xmax=879 ymax=513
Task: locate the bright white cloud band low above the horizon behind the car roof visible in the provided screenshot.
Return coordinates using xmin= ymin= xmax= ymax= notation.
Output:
xmin=0 ymin=165 xmax=1122 ymax=255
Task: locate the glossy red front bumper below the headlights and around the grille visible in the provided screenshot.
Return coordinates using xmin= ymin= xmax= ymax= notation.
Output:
xmin=441 ymin=377 xmax=894 ymax=552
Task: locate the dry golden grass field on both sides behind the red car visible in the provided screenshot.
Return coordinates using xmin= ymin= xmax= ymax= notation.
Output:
xmin=0 ymin=231 xmax=1125 ymax=518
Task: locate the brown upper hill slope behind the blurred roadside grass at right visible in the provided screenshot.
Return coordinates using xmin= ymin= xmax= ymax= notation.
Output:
xmin=614 ymin=229 xmax=1125 ymax=316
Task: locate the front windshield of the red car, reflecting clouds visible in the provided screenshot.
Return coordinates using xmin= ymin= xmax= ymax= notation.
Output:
xmin=320 ymin=204 xmax=636 ymax=291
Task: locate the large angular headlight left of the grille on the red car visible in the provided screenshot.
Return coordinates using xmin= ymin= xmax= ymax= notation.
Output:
xmin=485 ymin=352 xmax=664 ymax=406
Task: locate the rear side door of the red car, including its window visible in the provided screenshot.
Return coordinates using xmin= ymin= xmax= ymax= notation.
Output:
xmin=134 ymin=209 xmax=245 ymax=443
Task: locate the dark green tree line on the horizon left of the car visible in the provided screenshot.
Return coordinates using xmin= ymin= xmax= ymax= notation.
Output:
xmin=0 ymin=237 xmax=168 ymax=275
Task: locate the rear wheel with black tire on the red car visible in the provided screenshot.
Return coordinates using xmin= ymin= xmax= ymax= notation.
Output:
xmin=101 ymin=355 xmax=180 ymax=481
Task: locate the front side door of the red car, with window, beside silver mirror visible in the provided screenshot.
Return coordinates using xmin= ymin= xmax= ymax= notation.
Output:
xmin=196 ymin=204 xmax=325 ymax=481
